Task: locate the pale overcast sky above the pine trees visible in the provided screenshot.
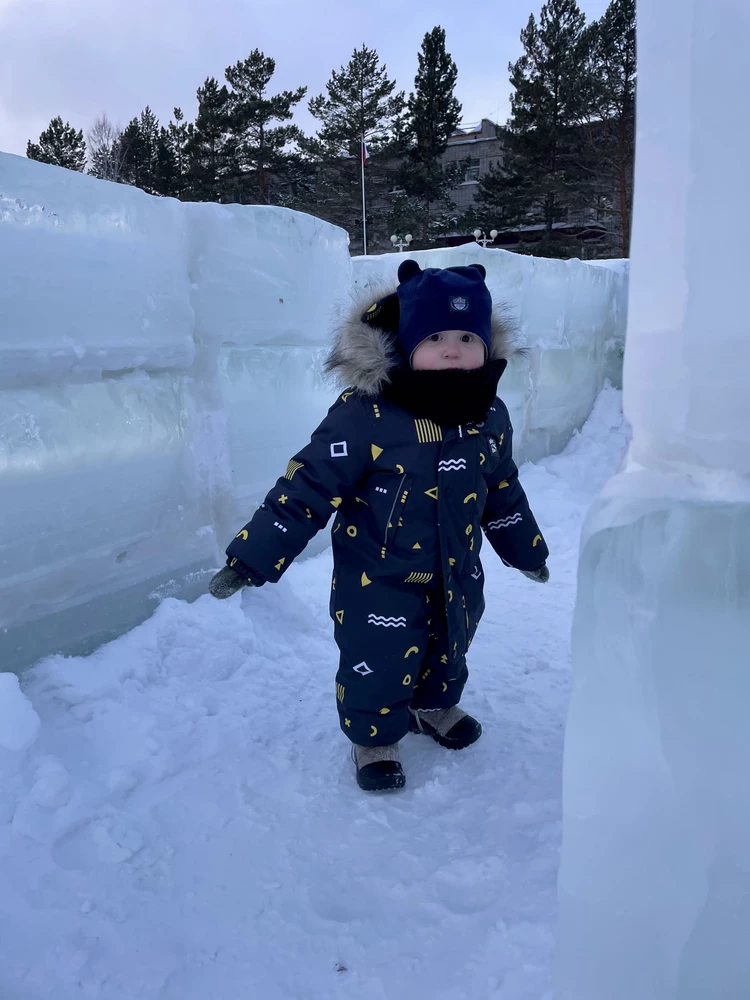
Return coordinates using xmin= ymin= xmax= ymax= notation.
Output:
xmin=0 ymin=0 xmax=607 ymax=153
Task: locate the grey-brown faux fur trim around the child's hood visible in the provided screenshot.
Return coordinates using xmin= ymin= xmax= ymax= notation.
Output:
xmin=325 ymin=287 xmax=523 ymax=396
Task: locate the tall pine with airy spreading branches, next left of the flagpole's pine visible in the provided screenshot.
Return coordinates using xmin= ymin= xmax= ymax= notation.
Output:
xmin=225 ymin=49 xmax=307 ymax=205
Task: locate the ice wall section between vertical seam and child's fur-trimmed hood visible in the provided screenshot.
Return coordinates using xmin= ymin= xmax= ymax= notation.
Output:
xmin=184 ymin=204 xmax=351 ymax=552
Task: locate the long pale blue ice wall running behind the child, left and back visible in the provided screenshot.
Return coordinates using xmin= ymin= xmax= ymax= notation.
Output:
xmin=0 ymin=154 xmax=625 ymax=668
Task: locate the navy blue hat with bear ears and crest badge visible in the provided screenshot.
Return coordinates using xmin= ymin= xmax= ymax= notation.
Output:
xmin=398 ymin=260 xmax=492 ymax=358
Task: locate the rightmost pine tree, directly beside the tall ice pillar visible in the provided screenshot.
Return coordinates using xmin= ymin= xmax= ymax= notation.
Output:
xmin=581 ymin=0 xmax=636 ymax=257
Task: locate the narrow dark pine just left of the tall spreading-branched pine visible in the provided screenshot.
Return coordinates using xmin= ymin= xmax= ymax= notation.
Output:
xmin=184 ymin=76 xmax=229 ymax=201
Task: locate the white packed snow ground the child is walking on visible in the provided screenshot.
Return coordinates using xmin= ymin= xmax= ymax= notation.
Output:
xmin=0 ymin=390 xmax=625 ymax=1000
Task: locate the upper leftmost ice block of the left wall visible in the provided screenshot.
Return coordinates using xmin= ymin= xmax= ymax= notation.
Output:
xmin=0 ymin=154 xmax=194 ymax=387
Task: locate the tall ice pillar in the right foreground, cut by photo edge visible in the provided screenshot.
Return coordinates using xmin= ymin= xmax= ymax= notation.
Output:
xmin=557 ymin=0 xmax=750 ymax=1000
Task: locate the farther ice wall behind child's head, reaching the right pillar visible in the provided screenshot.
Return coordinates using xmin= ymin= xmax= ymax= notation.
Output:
xmin=352 ymin=254 xmax=628 ymax=462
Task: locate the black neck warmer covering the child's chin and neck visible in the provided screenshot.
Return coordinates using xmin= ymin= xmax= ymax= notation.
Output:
xmin=382 ymin=360 xmax=508 ymax=427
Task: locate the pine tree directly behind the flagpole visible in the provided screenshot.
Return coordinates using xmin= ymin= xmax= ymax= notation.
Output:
xmin=306 ymin=45 xmax=404 ymax=253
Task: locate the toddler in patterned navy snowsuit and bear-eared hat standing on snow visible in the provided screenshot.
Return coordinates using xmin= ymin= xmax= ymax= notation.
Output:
xmin=210 ymin=260 xmax=549 ymax=791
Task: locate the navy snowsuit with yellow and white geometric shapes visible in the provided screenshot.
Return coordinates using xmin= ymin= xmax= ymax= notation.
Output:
xmin=227 ymin=378 xmax=548 ymax=745
